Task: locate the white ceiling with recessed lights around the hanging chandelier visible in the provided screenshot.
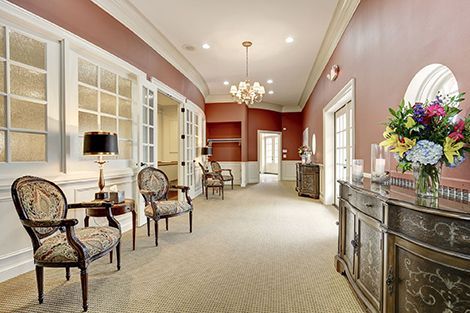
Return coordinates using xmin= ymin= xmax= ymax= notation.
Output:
xmin=126 ymin=0 xmax=338 ymax=106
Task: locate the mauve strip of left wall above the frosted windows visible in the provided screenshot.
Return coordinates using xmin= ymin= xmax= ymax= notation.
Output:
xmin=9 ymin=0 xmax=204 ymax=110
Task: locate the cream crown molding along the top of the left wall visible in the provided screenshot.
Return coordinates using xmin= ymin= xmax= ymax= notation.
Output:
xmin=92 ymin=0 xmax=209 ymax=96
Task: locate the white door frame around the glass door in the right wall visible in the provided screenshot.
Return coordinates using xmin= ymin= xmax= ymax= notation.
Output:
xmin=323 ymin=78 xmax=356 ymax=205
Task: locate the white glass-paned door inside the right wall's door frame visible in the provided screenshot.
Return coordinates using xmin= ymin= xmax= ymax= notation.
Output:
xmin=335 ymin=102 xmax=353 ymax=205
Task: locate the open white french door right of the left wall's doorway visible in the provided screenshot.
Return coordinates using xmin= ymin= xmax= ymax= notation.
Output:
xmin=180 ymin=102 xmax=205 ymax=197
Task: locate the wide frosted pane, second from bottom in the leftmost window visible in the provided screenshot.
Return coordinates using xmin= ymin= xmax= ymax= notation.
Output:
xmin=10 ymin=98 xmax=47 ymax=131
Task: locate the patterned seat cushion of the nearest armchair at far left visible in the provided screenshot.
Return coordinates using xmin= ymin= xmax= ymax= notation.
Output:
xmin=34 ymin=226 xmax=121 ymax=263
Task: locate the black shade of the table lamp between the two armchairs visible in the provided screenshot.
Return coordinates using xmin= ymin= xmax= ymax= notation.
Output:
xmin=83 ymin=131 xmax=119 ymax=155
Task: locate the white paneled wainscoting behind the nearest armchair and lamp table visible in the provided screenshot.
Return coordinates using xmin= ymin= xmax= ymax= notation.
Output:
xmin=0 ymin=169 xmax=140 ymax=282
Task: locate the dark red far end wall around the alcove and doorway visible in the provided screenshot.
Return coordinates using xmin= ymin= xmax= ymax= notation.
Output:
xmin=205 ymin=103 xmax=302 ymax=161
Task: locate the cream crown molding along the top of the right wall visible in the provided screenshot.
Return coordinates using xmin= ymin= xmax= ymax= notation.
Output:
xmin=298 ymin=0 xmax=361 ymax=111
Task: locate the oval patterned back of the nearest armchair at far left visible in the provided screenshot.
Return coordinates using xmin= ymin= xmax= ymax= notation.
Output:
xmin=11 ymin=176 xmax=67 ymax=250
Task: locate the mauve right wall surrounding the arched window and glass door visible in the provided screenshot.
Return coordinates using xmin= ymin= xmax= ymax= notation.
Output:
xmin=303 ymin=0 xmax=470 ymax=188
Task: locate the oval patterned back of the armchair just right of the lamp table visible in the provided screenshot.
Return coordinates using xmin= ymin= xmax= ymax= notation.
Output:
xmin=137 ymin=166 xmax=170 ymax=201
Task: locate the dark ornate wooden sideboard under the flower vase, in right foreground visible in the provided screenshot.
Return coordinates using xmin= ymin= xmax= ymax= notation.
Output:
xmin=335 ymin=180 xmax=470 ymax=313
